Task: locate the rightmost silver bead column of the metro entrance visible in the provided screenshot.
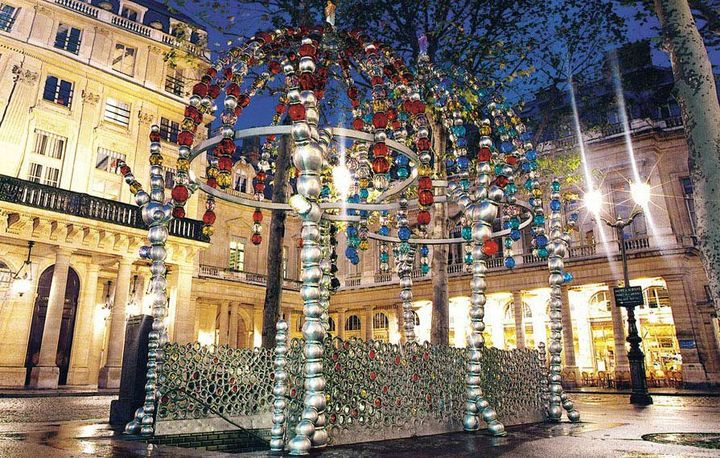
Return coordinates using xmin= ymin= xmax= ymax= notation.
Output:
xmin=548 ymin=186 xmax=580 ymax=421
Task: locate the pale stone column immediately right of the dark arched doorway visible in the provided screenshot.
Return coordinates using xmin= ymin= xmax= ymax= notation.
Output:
xmin=68 ymin=261 xmax=100 ymax=385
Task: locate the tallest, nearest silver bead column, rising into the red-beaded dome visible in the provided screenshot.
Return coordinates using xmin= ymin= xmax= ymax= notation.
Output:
xmin=288 ymin=39 xmax=327 ymax=455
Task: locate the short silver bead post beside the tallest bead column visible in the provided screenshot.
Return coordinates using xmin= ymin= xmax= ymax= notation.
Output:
xmin=270 ymin=319 xmax=288 ymax=452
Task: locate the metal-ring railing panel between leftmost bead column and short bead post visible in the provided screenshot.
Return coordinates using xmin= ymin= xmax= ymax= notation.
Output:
xmin=157 ymin=343 xmax=274 ymax=429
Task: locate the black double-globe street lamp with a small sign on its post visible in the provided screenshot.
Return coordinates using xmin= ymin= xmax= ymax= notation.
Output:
xmin=584 ymin=182 xmax=653 ymax=406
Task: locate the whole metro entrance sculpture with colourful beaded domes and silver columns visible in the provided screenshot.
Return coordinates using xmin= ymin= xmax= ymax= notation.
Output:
xmin=116 ymin=17 xmax=579 ymax=454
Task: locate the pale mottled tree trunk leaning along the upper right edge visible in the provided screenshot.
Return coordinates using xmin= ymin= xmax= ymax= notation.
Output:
xmin=654 ymin=0 xmax=720 ymax=312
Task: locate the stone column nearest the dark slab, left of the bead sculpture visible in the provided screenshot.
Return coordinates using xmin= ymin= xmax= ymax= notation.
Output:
xmin=98 ymin=258 xmax=132 ymax=388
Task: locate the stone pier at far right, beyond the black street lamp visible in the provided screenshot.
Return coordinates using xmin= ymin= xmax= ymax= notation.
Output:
xmin=668 ymin=275 xmax=708 ymax=385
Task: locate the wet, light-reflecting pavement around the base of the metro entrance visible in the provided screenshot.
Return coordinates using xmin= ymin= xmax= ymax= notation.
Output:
xmin=0 ymin=394 xmax=720 ymax=458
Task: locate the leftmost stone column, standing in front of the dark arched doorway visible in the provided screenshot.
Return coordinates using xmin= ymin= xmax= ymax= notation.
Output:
xmin=30 ymin=247 xmax=72 ymax=388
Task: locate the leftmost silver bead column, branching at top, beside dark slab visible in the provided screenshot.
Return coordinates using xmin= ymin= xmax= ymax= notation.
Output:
xmin=125 ymin=125 xmax=173 ymax=435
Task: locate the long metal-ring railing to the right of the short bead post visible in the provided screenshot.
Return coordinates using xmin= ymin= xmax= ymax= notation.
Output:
xmin=287 ymin=338 xmax=545 ymax=444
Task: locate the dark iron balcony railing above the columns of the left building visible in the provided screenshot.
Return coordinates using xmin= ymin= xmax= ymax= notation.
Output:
xmin=0 ymin=175 xmax=207 ymax=242
